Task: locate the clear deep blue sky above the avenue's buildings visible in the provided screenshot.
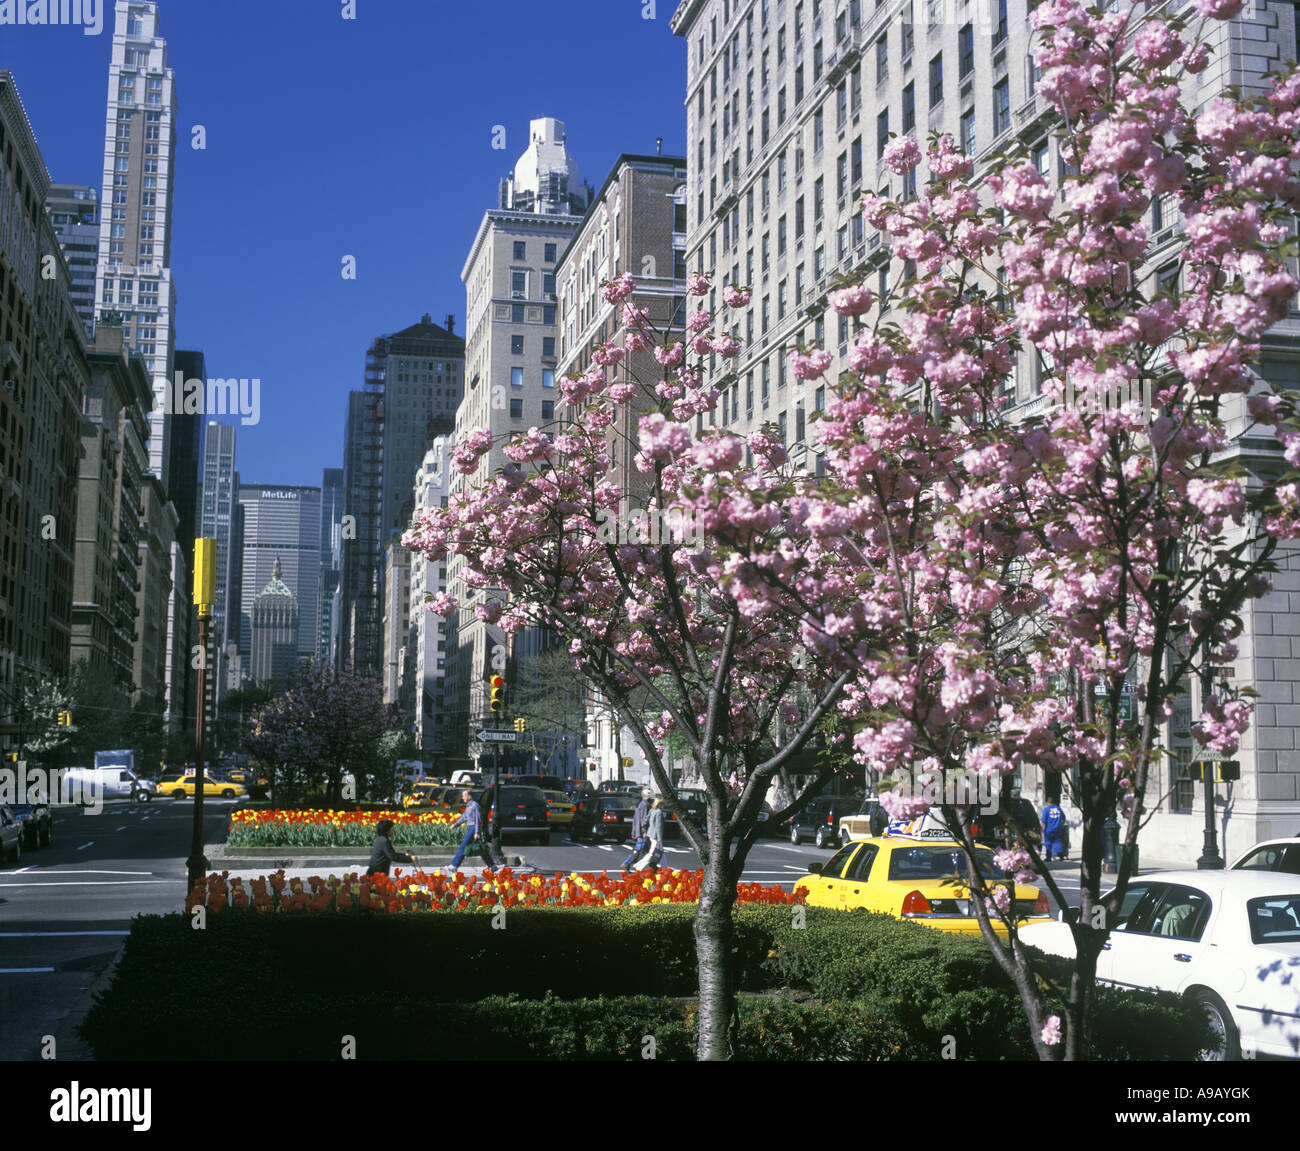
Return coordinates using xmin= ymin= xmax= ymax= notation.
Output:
xmin=0 ymin=0 xmax=686 ymax=484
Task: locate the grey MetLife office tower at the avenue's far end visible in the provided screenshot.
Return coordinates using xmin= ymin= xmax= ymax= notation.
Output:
xmin=230 ymin=484 xmax=321 ymax=675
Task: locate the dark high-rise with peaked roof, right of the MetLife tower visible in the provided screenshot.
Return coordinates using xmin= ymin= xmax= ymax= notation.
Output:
xmin=341 ymin=315 xmax=465 ymax=675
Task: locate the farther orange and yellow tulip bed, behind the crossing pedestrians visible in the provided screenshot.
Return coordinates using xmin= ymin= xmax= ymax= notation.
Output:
xmin=226 ymin=809 xmax=464 ymax=849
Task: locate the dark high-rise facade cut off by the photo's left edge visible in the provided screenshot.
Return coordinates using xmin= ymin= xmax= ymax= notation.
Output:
xmin=0 ymin=70 xmax=90 ymax=691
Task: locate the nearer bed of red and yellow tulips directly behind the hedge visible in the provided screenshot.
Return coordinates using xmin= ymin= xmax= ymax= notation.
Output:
xmin=185 ymin=867 xmax=805 ymax=914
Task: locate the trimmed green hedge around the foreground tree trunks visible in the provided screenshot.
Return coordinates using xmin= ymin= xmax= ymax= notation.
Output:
xmin=83 ymin=905 xmax=1205 ymax=1060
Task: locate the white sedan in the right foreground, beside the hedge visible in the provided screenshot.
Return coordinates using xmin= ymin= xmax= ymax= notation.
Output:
xmin=1021 ymin=870 xmax=1300 ymax=1059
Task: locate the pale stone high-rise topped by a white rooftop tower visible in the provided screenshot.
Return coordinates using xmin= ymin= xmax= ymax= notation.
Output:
xmin=447 ymin=118 xmax=592 ymax=753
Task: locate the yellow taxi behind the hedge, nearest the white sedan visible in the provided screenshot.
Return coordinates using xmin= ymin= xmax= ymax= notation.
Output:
xmin=794 ymin=835 xmax=1050 ymax=938
